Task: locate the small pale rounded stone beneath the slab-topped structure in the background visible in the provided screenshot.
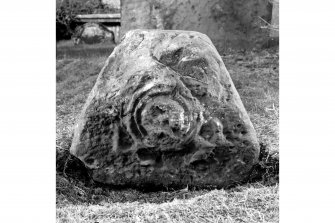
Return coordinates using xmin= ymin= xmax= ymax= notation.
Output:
xmin=73 ymin=23 xmax=115 ymax=44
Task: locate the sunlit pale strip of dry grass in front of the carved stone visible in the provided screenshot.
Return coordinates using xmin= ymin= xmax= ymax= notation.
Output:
xmin=57 ymin=184 xmax=279 ymax=223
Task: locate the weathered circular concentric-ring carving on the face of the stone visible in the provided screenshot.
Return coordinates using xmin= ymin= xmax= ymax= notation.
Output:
xmin=125 ymin=71 xmax=203 ymax=151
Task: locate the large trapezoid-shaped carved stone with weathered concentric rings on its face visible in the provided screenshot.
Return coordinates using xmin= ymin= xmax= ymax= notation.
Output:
xmin=71 ymin=30 xmax=259 ymax=187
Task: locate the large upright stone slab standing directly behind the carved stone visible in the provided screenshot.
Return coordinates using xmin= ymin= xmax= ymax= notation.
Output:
xmin=120 ymin=0 xmax=272 ymax=52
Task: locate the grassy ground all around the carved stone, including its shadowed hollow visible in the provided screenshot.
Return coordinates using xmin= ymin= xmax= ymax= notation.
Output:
xmin=56 ymin=42 xmax=279 ymax=223
